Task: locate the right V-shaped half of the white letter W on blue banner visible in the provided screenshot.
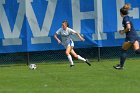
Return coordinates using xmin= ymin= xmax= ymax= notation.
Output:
xmin=26 ymin=0 xmax=57 ymax=44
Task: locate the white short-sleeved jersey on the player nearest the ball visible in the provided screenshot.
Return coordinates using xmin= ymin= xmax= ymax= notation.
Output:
xmin=56 ymin=27 xmax=76 ymax=47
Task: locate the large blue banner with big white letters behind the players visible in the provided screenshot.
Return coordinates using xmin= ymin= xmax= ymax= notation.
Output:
xmin=0 ymin=0 xmax=140 ymax=53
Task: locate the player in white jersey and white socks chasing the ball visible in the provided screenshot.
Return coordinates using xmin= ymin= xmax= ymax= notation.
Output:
xmin=54 ymin=20 xmax=91 ymax=67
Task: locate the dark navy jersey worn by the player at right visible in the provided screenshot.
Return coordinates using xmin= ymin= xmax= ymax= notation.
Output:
xmin=122 ymin=16 xmax=137 ymax=38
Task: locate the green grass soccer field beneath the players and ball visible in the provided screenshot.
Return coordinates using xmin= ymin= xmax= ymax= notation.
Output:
xmin=0 ymin=58 xmax=140 ymax=93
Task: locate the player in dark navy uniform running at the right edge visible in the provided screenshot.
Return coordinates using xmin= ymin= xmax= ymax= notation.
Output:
xmin=113 ymin=4 xmax=140 ymax=69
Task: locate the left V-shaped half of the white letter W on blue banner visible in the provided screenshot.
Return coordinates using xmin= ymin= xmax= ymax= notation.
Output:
xmin=0 ymin=0 xmax=25 ymax=46
